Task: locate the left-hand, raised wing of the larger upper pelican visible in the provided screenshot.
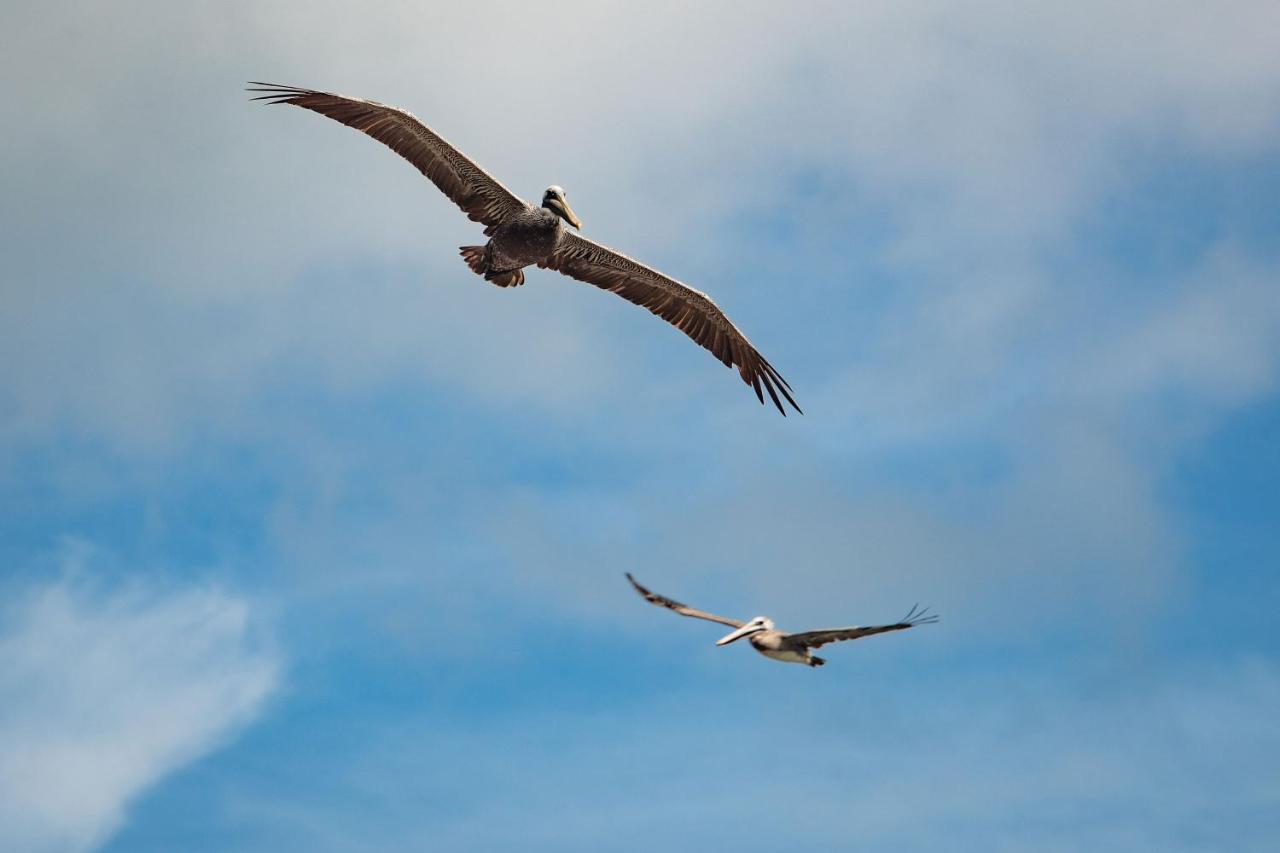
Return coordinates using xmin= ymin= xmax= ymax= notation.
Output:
xmin=248 ymin=82 xmax=526 ymax=233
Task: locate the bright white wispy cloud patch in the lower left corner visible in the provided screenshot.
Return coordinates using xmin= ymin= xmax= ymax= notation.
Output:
xmin=0 ymin=563 xmax=278 ymax=853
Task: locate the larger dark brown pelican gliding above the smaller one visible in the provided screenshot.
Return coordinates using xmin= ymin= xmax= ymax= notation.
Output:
xmin=248 ymin=82 xmax=800 ymax=416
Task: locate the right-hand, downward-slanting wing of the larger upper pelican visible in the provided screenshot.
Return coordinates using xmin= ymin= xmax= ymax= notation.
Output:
xmin=539 ymin=233 xmax=803 ymax=415
